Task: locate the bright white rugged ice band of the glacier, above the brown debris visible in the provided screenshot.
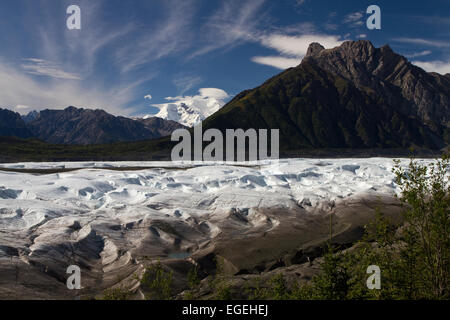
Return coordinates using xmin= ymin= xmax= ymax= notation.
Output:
xmin=0 ymin=158 xmax=432 ymax=231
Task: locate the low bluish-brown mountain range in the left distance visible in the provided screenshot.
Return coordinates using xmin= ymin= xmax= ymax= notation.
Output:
xmin=0 ymin=107 xmax=184 ymax=145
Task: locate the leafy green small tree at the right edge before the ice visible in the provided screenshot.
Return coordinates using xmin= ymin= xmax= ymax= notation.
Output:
xmin=394 ymin=156 xmax=450 ymax=299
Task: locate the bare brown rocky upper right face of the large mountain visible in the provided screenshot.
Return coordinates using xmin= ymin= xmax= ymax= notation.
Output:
xmin=309 ymin=40 xmax=450 ymax=143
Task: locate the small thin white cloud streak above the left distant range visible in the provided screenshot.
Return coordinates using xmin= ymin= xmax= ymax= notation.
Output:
xmin=21 ymin=58 xmax=81 ymax=80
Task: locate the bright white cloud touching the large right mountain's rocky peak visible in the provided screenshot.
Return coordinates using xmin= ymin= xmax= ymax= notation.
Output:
xmin=252 ymin=34 xmax=342 ymax=69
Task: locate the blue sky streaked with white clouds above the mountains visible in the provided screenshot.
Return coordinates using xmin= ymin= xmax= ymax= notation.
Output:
xmin=0 ymin=0 xmax=450 ymax=116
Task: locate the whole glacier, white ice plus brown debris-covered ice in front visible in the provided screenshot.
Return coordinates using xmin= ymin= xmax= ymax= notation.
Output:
xmin=0 ymin=158 xmax=433 ymax=298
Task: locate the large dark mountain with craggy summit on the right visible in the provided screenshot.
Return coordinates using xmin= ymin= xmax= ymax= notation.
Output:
xmin=203 ymin=41 xmax=450 ymax=150
